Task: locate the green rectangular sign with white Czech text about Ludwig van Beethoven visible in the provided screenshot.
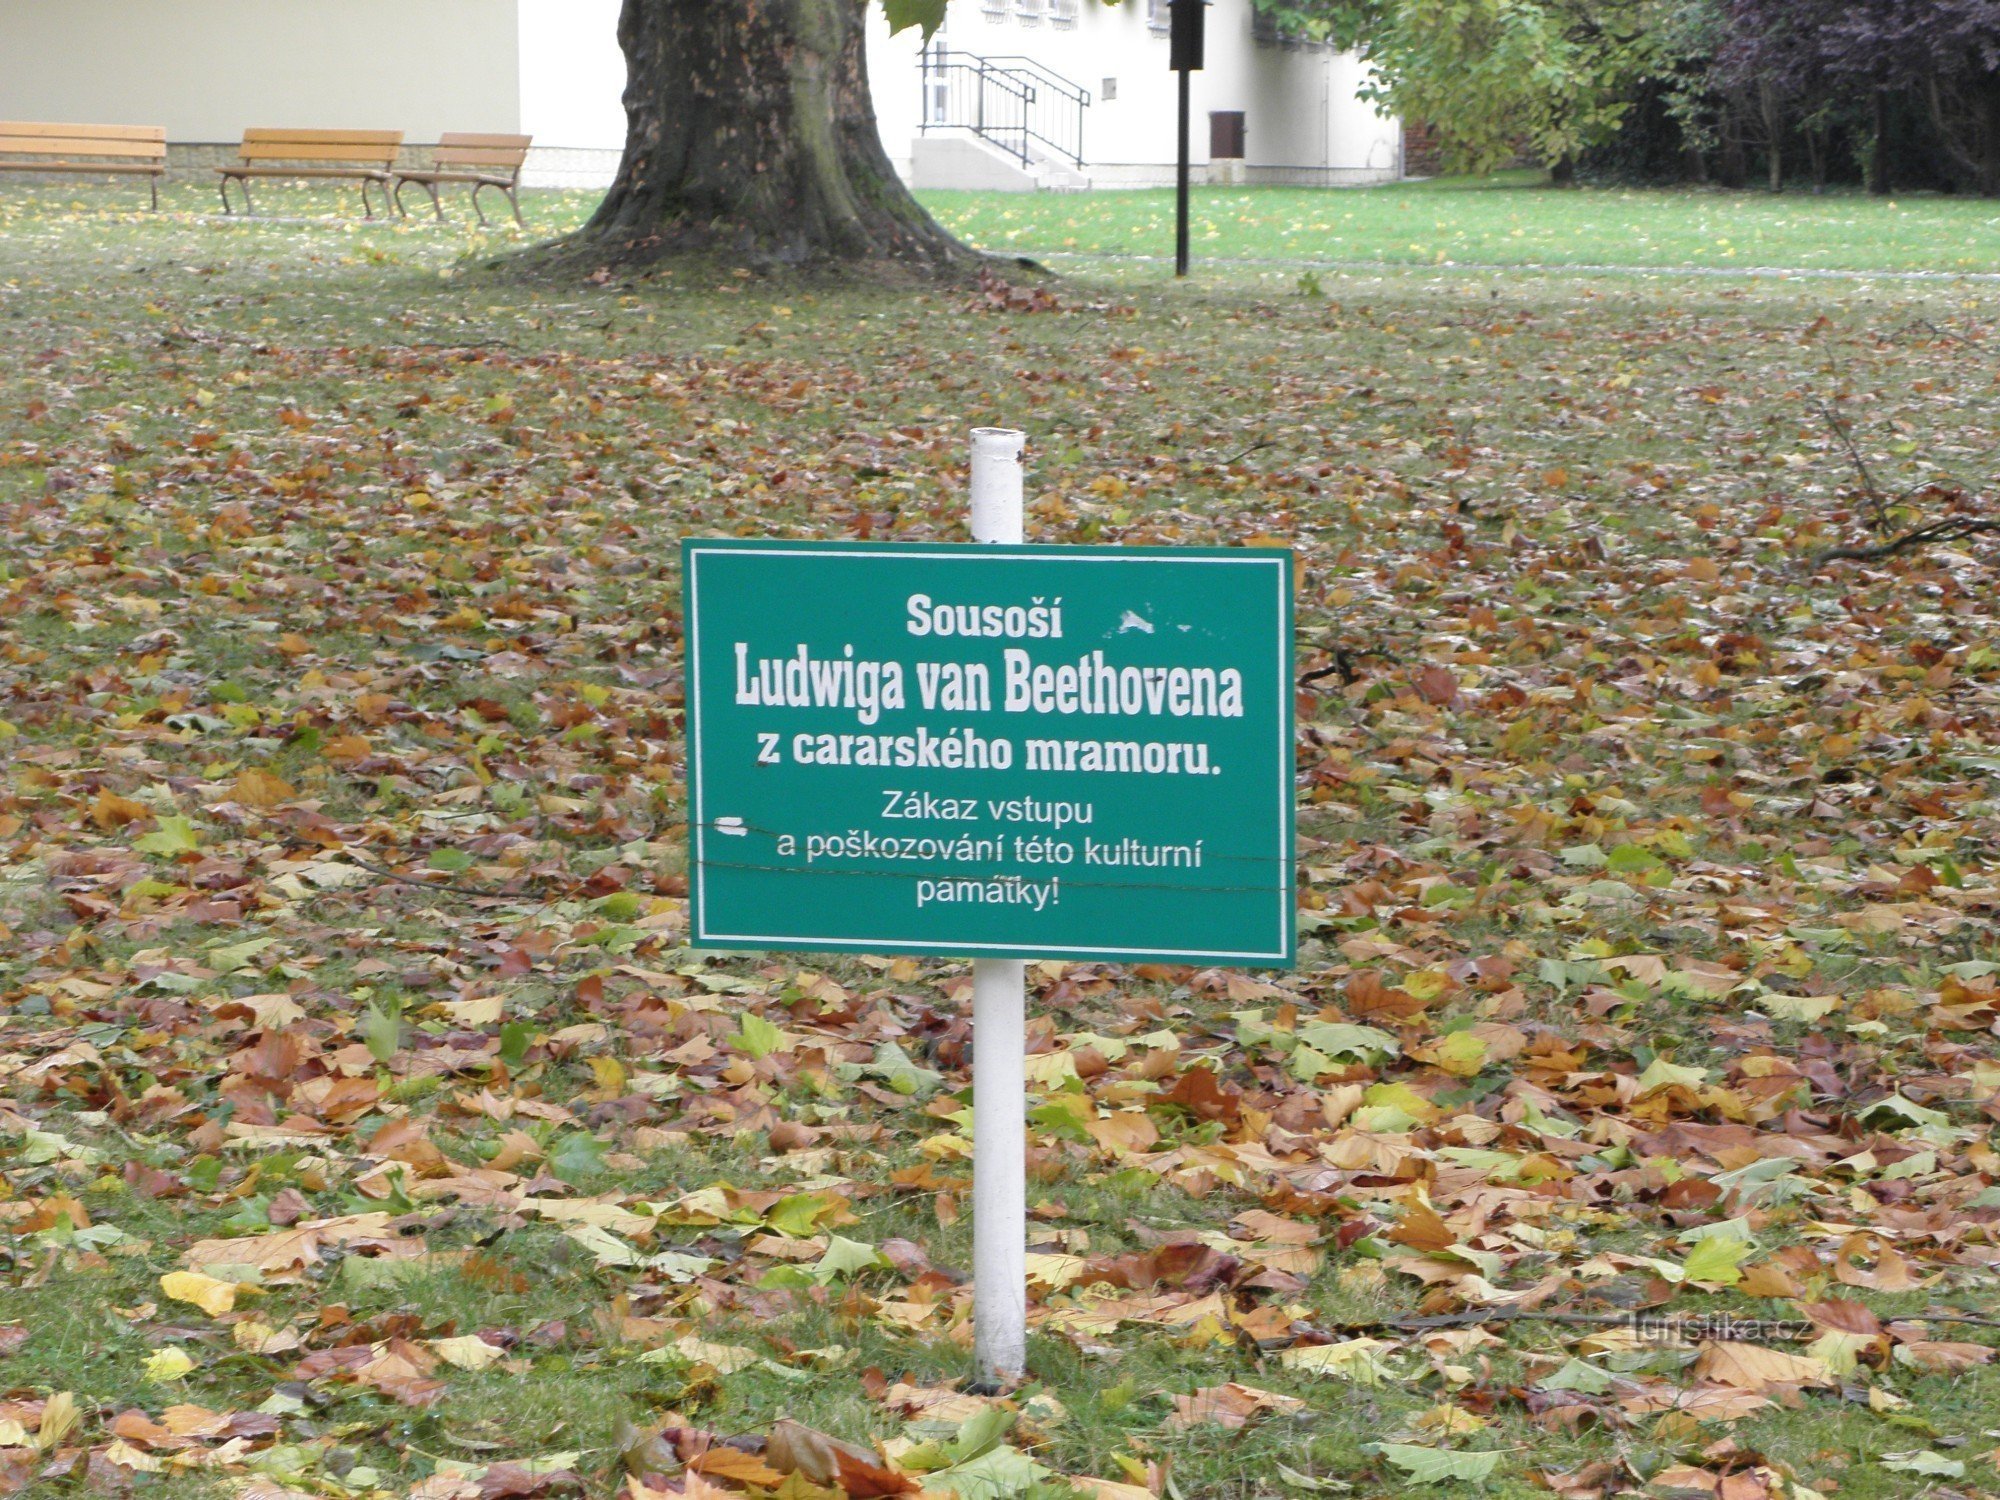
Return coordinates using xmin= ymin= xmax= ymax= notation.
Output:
xmin=682 ymin=540 xmax=1296 ymax=966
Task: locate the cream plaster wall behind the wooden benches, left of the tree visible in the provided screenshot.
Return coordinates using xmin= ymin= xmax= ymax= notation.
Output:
xmin=0 ymin=0 xmax=520 ymax=142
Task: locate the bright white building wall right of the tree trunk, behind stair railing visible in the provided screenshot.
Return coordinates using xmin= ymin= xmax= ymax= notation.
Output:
xmin=868 ymin=0 xmax=1400 ymax=186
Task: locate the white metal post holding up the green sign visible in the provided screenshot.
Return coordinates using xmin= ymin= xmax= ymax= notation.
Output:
xmin=972 ymin=428 xmax=1028 ymax=1386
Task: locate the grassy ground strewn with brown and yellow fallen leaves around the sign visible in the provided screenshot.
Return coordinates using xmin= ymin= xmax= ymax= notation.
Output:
xmin=0 ymin=188 xmax=2000 ymax=1500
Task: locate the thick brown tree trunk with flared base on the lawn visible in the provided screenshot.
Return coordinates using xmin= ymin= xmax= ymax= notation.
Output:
xmin=578 ymin=0 xmax=970 ymax=268
